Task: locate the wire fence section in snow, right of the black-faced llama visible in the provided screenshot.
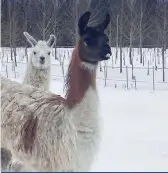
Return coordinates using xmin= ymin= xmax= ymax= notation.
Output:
xmin=102 ymin=66 xmax=168 ymax=90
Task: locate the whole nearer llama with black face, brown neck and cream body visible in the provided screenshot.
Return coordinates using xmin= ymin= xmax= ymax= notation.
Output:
xmin=1 ymin=12 xmax=111 ymax=171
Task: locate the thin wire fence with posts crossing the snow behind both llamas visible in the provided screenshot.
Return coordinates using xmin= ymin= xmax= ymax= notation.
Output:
xmin=1 ymin=62 xmax=168 ymax=90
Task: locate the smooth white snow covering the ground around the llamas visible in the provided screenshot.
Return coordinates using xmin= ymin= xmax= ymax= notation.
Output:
xmin=1 ymin=47 xmax=168 ymax=171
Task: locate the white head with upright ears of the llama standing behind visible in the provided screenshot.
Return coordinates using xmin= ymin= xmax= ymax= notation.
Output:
xmin=23 ymin=32 xmax=56 ymax=70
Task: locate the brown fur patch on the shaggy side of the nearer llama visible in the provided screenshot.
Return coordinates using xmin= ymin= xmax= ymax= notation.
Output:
xmin=19 ymin=115 xmax=38 ymax=153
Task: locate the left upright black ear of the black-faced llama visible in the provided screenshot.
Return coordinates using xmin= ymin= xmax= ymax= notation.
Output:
xmin=78 ymin=11 xmax=91 ymax=35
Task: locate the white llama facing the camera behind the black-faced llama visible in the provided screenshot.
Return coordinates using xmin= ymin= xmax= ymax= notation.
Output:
xmin=23 ymin=32 xmax=55 ymax=90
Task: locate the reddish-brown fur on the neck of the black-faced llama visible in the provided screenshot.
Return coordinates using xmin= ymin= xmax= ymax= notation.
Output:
xmin=66 ymin=48 xmax=96 ymax=108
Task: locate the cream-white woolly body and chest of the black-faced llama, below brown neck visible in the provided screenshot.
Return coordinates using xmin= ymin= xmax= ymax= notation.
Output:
xmin=1 ymin=49 xmax=100 ymax=171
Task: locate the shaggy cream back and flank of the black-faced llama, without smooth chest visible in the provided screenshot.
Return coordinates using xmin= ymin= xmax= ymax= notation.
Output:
xmin=1 ymin=79 xmax=76 ymax=171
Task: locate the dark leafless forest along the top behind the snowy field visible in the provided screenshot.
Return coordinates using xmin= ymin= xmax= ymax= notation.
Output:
xmin=1 ymin=0 xmax=168 ymax=49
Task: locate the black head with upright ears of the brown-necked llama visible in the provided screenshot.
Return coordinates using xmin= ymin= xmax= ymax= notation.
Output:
xmin=78 ymin=12 xmax=111 ymax=68
